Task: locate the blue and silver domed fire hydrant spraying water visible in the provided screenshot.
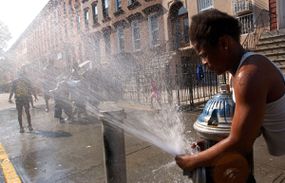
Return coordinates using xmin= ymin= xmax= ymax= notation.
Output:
xmin=193 ymin=85 xmax=253 ymax=182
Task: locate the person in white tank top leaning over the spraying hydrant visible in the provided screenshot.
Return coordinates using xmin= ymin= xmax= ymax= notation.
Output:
xmin=175 ymin=9 xmax=285 ymax=182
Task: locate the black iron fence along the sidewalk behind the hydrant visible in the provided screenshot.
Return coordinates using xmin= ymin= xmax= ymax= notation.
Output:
xmin=120 ymin=64 xmax=218 ymax=107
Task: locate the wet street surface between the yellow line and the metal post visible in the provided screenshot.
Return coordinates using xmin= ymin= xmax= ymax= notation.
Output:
xmin=1 ymin=106 xmax=104 ymax=182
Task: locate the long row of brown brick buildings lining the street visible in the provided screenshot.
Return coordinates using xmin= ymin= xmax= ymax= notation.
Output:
xmin=7 ymin=0 xmax=284 ymax=105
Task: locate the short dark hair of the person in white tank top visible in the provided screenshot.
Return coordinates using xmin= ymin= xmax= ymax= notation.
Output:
xmin=189 ymin=9 xmax=241 ymax=47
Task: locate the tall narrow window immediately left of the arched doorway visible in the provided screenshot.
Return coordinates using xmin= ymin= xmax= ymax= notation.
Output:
xmin=148 ymin=15 xmax=159 ymax=47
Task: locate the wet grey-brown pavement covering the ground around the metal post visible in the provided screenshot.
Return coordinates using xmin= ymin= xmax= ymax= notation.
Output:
xmin=0 ymin=93 xmax=285 ymax=183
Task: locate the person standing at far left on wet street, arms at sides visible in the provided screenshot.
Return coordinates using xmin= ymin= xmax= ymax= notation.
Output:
xmin=8 ymin=71 xmax=37 ymax=133
